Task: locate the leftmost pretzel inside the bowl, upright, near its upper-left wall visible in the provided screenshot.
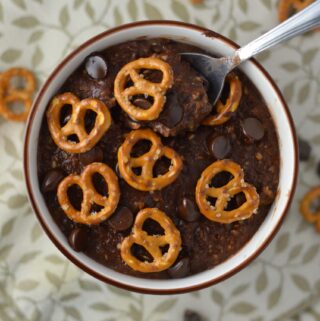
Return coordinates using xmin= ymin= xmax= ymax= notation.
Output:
xmin=47 ymin=93 xmax=111 ymax=153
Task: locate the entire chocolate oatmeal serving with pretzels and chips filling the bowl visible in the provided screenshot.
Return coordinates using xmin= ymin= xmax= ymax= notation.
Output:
xmin=38 ymin=39 xmax=279 ymax=279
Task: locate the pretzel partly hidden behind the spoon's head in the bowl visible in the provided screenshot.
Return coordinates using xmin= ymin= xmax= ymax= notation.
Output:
xmin=202 ymin=74 xmax=242 ymax=126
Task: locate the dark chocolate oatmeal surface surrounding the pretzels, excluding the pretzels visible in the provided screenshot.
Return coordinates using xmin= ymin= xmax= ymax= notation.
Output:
xmin=38 ymin=39 xmax=279 ymax=279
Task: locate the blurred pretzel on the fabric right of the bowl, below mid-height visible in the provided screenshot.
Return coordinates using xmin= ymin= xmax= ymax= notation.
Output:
xmin=300 ymin=186 xmax=320 ymax=232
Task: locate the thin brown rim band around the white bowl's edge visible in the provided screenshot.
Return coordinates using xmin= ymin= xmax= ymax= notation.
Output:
xmin=23 ymin=20 xmax=298 ymax=294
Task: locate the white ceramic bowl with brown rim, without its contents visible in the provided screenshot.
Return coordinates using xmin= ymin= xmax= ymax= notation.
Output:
xmin=24 ymin=21 xmax=298 ymax=294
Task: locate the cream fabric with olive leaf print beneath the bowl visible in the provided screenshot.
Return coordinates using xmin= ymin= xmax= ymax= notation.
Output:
xmin=0 ymin=0 xmax=320 ymax=321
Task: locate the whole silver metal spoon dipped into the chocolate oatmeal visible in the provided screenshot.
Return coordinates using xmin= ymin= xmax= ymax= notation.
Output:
xmin=181 ymin=0 xmax=320 ymax=104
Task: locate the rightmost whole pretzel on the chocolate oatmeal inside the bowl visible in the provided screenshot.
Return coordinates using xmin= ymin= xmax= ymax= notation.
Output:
xmin=196 ymin=159 xmax=259 ymax=223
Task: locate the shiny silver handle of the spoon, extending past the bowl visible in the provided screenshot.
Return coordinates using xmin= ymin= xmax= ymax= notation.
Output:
xmin=234 ymin=0 xmax=320 ymax=64
